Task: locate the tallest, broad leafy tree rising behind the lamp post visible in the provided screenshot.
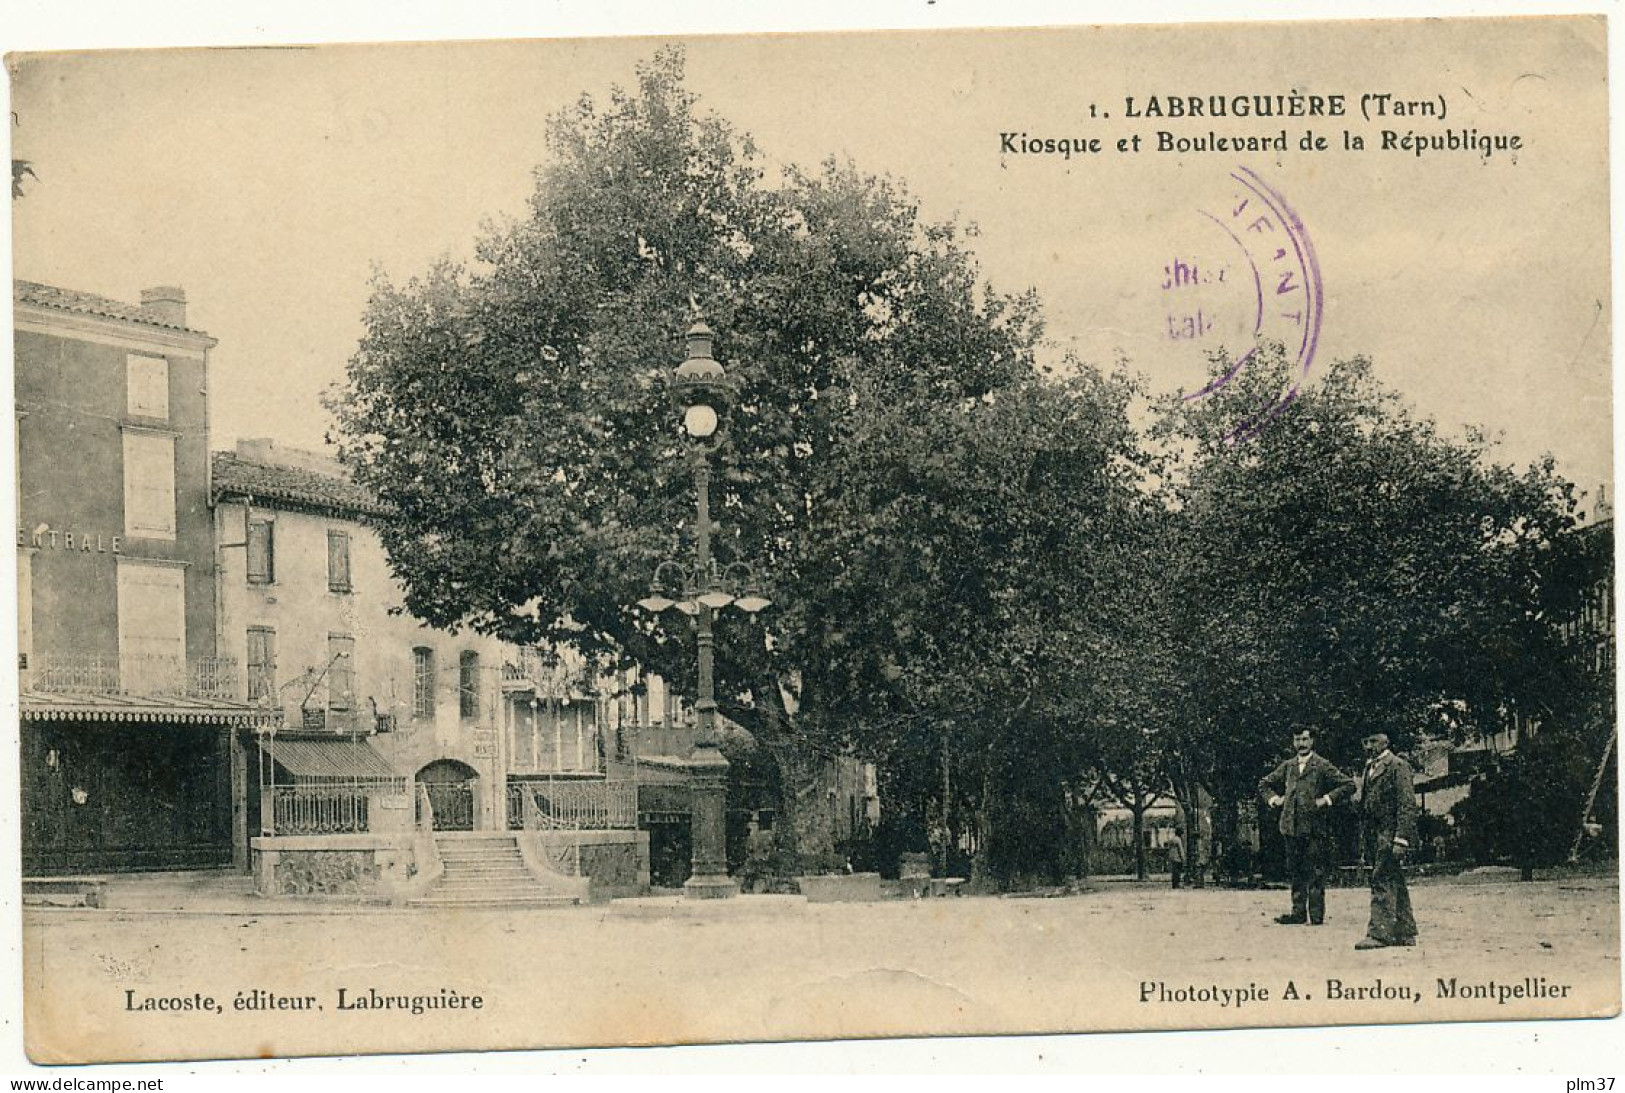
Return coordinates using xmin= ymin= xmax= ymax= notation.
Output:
xmin=332 ymin=50 xmax=1128 ymax=876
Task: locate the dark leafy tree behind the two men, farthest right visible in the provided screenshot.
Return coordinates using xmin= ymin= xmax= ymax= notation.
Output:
xmin=1165 ymin=345 xmax=1576 ymax=864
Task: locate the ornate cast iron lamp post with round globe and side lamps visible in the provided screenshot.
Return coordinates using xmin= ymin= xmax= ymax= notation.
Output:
xmin=639 ymin=323 xmax=770 ymax=900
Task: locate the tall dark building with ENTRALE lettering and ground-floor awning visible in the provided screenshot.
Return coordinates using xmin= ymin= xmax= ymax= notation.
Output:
xmin=13 ymin=281 xmax=279 ymax=875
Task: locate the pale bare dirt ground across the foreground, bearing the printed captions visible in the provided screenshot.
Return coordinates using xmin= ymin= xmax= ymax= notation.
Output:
xmin=24 ymin=879 xmax=1620 ymax=1061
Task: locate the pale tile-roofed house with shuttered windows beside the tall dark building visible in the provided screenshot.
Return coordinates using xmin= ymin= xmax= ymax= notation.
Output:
xmin=213 ymin=438 xmax=516 ymax=836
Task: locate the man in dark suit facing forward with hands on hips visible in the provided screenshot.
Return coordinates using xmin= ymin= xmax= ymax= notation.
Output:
xmin=1258 ymin=728 xmax=1354 ymax=926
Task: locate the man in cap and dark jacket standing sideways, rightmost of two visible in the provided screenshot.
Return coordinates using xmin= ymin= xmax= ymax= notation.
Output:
xmin=1355 ymin=732 xmax=1417 ymax=948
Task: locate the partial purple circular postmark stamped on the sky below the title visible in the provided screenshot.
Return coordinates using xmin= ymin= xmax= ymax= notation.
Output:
xmin=1162 ymin=167 xmax=1324 ymax=440
